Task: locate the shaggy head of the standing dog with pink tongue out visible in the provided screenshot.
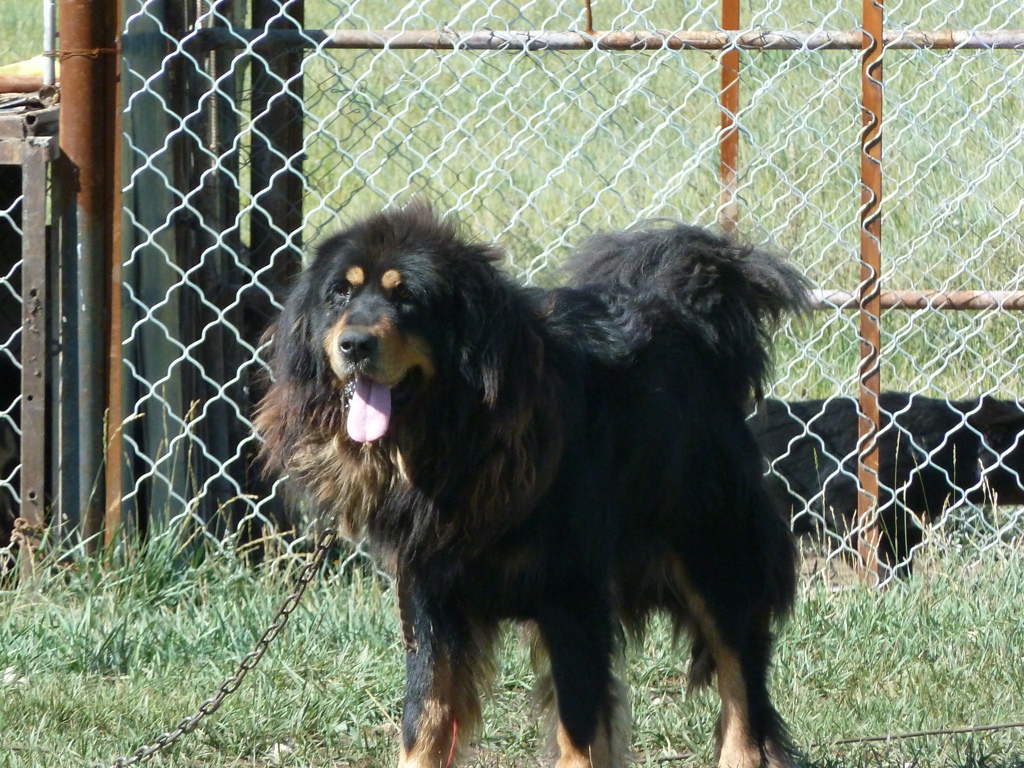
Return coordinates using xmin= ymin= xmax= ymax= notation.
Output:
xmin=260 ymin=202 xmax=532 ymax=442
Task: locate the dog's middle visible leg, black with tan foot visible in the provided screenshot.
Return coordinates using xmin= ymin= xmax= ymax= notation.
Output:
xmin=537 ymin=604 xmax=629 ymax=768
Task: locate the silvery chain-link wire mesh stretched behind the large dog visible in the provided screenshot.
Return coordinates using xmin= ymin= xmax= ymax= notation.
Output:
xmin=114 ymin=0 xmax=1024 ymax=585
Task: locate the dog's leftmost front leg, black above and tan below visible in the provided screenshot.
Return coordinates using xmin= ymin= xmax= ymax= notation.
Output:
xmin=398 ymin=588 xmax=484 ymax=768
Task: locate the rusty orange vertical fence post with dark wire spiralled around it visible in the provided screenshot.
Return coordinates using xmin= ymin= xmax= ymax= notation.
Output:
xmin=857 ymin=0 xmax=885 ymax=584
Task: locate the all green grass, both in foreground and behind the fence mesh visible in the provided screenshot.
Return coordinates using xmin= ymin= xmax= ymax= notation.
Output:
xmin=6 ymin=0 xmax=1024 ymax=768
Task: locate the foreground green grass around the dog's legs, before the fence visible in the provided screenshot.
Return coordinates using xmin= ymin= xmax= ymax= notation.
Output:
xmin=0 ymin=550 xmax=1024 ymax=768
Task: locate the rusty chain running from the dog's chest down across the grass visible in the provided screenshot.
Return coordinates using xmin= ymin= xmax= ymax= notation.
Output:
xmin=113 ymin=529 xmax=335 ymax=768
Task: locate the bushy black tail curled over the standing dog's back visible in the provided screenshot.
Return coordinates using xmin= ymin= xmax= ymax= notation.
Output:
xmin=567 ymin=222 xmax=809 ymax=396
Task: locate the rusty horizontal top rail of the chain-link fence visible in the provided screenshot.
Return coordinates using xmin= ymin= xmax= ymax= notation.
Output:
xmin=188 ymin=27 xmax=1024 ymax=51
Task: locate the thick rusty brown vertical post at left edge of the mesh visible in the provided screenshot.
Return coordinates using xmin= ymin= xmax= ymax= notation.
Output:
xmin=59 ymin=0 xmax=117 ymax=550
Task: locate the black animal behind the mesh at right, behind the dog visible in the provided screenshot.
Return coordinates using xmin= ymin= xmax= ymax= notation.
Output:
xmin=751 ymin=392 xmax=1024 ymax=574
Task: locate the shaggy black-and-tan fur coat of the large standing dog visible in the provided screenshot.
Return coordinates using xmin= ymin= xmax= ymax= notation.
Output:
xmin=257 ymin=204 xmax=806 ymax=768
